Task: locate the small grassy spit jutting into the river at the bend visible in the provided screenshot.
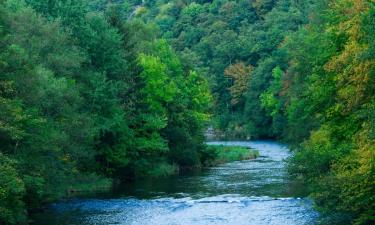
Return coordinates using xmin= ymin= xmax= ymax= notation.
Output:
xmin=202 ymin=145 xmax=259 ymax=167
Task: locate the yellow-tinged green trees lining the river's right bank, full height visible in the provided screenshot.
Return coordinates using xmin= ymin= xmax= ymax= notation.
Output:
xmin=284 ymin=0 xmax=375 ymax=224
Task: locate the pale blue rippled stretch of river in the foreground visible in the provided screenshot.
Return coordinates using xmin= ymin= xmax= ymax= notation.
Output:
xmin=44 ymin=195 xmax=317 ymax=225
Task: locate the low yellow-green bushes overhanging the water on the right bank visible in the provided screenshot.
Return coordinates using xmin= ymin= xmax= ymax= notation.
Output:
xmin=289 ymin=126 xmax=375 ymax=224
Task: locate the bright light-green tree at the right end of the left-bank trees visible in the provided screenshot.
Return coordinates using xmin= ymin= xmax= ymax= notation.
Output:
xmin=134 ymin=40 xmax=211 ymax=167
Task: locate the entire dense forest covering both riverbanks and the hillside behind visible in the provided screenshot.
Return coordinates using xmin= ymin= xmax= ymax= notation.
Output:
xmin=0 ymin=0 xmax=375 ymax=224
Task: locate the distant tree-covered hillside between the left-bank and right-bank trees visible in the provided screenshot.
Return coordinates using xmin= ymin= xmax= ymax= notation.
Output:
xmin=129 ymin=0 xmax=307 ymax=137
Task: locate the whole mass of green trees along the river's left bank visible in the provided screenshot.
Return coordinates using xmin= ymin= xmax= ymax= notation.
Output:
xmin=0 ymin=0 xmax=211 ymax=224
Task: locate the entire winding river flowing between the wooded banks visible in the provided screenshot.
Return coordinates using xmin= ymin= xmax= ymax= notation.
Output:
xmin=35 ymin=141 xmax=318 ymax=225
